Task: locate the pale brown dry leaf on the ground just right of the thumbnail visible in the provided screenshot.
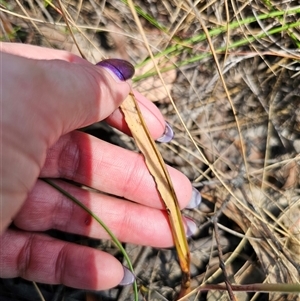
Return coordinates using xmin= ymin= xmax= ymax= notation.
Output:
xmin=134 ymin=58 xmax=176 ymax=102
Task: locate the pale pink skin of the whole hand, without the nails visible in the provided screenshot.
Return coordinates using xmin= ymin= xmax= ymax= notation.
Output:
xmin=0 ymin=43 xmax=192 ymax=290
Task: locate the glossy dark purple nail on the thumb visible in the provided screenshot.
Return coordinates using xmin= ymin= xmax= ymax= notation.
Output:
xmin=96 ymin=59 xmax=134 ymax=81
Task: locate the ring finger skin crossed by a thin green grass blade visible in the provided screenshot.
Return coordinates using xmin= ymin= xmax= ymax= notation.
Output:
xmin=14 ymin=180 xmax=178 ymax=248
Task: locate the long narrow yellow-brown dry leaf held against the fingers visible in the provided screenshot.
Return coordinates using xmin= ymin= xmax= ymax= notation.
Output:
xmin=120 ymin=92 xmax=190 ymax=297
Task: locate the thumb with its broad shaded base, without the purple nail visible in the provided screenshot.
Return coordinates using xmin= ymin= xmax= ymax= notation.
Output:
xmin=0 ymin=48 xmax=129 ymax=231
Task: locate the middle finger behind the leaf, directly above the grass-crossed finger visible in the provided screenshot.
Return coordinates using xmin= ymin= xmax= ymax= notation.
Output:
xmin=40 ymin=132 xmax=192 ymax=209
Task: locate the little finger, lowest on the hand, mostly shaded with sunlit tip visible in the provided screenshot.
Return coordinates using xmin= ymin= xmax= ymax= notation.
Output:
xmin=0 ymin=229 xmax=124 ymax=290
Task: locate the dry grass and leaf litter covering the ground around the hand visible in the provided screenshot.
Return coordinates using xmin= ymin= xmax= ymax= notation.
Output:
xmin=0 ymin=0 xmax=300 ymax=301
